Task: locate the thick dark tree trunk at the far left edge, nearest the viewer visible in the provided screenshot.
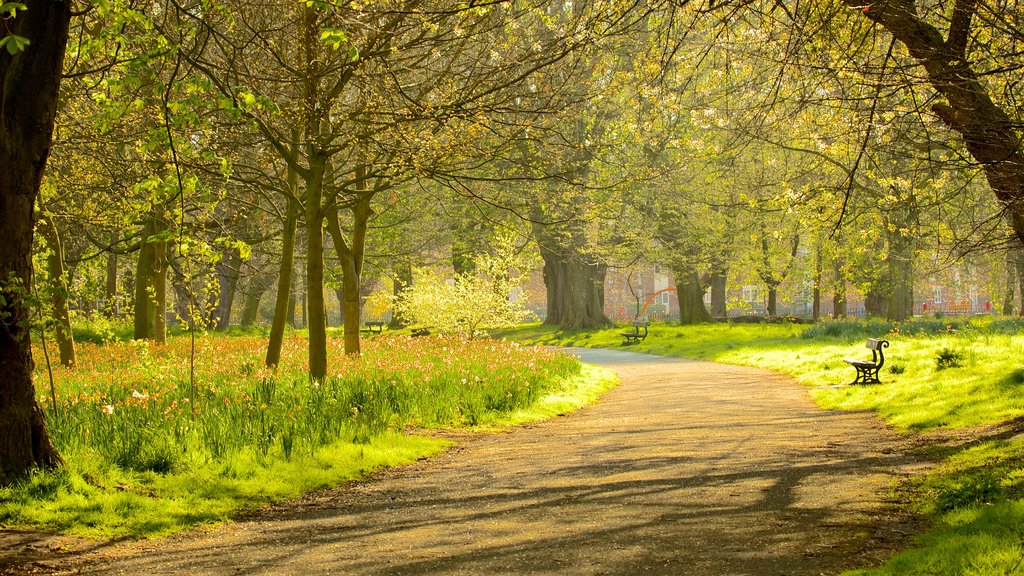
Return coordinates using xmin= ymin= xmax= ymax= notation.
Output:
xmin=0 ymin=0 xmax=72 ymax=485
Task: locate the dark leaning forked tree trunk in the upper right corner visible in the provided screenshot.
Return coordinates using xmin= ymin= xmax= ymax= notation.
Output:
xmin=845 ymin=0 xmax=1024 ymax=241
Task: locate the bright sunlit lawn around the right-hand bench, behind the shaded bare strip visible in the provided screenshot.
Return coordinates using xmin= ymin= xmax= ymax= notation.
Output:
xmin=500 ymin=320 xmax=1024 ymax=430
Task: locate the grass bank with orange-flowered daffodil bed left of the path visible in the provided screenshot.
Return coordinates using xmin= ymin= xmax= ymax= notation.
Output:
xmin=0 ymin=336 xmax=615 ymax=538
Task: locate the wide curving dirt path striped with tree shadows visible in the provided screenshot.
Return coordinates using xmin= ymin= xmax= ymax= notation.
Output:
xmin=8 ymin=351 xmax=913 ymax=576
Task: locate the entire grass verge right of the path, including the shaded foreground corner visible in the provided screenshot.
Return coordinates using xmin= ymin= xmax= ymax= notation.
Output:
xmin=500 ymin=318 xmax=1024 ymax=576
